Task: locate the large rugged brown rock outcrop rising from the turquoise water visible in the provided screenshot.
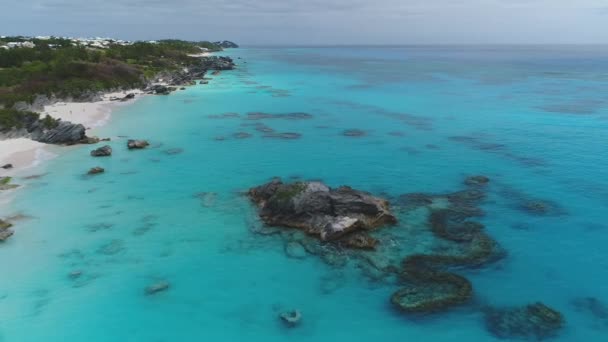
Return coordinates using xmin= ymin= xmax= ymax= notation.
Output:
xmin=249 ymin=179 xmax=397 ymax=241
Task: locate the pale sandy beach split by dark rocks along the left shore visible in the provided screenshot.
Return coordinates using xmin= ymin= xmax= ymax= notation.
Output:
xmin=0 ymin=89 xmax=145 ymax=177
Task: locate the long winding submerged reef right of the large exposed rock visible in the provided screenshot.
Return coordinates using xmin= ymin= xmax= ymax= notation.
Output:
xmin=391 ymin=176 xmax=504 ymax=313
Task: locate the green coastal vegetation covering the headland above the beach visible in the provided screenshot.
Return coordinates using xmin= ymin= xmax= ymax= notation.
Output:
xmin=0 ymin=37 xmax=222 ymax=108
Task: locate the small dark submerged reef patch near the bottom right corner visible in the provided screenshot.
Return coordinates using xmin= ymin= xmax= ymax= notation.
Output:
xmin=485 ymin=302 xmax=565 ymax=341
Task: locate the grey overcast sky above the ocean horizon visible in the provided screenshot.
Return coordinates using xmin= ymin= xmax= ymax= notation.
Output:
xmin=0 ymin=0 xmax=608 ymax=45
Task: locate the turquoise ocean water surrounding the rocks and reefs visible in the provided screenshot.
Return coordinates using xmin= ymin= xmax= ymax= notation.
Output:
xmin=0 ymin=46 xmax=608 ymax=342
